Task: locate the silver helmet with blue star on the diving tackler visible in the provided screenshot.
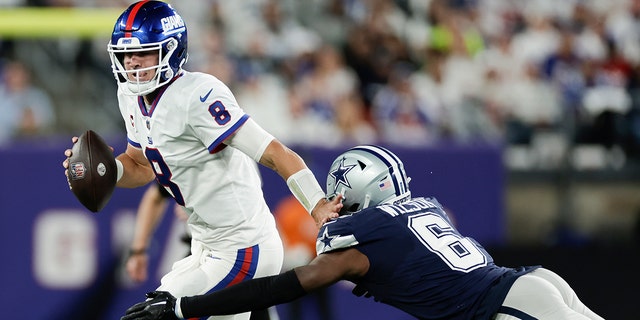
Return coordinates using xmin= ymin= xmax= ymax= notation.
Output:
xmin=327 ymin=145 xmax=411 ymax=215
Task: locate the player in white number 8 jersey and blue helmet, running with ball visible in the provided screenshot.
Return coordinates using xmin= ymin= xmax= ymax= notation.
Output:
xmin=63 ymin=1 xmax=342 ymax=319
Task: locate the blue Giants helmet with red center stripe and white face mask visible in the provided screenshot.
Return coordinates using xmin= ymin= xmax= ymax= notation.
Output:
xmin=107 ymin=1 xmax=189 ymax=95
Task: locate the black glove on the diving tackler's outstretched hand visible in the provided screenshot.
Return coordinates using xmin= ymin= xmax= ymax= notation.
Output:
xmin=120 ymin=291 xmax=178 ymax=320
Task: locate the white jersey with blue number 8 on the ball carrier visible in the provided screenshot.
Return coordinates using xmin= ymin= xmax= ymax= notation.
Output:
xmin=118 ymin=71 xmax=277 ymax=250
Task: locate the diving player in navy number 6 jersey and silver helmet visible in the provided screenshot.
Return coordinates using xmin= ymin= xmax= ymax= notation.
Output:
xmin=122 ymin=146 xmax=602 ymax=320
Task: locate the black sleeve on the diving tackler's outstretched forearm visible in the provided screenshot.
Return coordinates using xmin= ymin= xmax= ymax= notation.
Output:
xmin=180 ymin=270 xmax=306 ymax=319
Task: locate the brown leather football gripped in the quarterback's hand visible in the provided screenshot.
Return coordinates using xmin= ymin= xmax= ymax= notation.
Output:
xmin=67 ymin=130 xmax=118 ymax=212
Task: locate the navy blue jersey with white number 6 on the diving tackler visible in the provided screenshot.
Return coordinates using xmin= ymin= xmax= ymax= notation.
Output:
xmin=316 ymin=198 xmax=528 ymax=319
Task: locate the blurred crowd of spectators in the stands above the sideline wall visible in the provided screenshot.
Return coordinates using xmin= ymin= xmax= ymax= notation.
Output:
xmin=0 ymin=0 xmax=640 ymax=169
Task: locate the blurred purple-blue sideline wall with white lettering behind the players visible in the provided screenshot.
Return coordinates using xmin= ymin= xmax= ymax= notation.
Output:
xmin=0 ymin=137 xmax=505 ymax=320
